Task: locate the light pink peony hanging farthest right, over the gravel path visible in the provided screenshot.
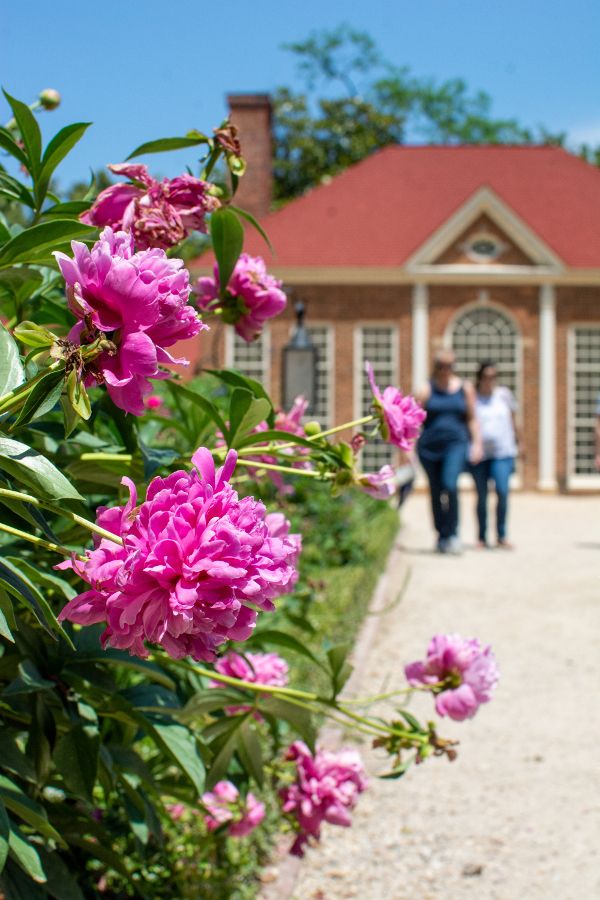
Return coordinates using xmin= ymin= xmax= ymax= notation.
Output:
xmin=404 ymin=634 xmax=498 ymax=722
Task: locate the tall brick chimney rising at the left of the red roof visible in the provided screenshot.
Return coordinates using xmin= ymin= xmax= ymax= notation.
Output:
xmin=227 ymin=94 xmax=273 ymax=219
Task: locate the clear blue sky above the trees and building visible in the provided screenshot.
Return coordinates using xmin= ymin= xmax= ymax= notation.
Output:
xmin=0 ymin=0 xmax=600 ymax=184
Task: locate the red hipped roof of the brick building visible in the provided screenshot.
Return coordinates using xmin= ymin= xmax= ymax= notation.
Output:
xmin=233 ymin=146 xmax=600 ymax=268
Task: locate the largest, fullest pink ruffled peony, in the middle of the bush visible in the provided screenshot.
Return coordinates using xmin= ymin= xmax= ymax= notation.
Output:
xmin=60 ymin=447 xmax=300 ymax=662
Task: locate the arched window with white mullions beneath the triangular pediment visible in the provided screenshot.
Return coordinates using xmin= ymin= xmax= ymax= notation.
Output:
xmin=451 ymin=306 xmax=521 ymax=399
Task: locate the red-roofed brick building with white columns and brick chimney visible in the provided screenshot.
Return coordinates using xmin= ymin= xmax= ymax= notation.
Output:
xmin=193 ymin=95 xmax=600 ymax=490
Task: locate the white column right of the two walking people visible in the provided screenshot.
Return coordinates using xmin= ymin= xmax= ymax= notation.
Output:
xmin=538 ymin=284 xmax=557 ymax=491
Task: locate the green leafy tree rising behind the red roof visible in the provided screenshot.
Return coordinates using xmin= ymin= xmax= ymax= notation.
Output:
xmin=274 ymin=25 xmax=533 ymax=200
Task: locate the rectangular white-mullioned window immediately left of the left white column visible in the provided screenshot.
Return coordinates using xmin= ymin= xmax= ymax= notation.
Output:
xmin=357 ymin=325 xmax=398 ymax=472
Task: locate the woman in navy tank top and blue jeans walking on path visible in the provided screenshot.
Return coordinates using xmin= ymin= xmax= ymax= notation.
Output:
xmin=417 ymin=350 xmax=482 ymax=553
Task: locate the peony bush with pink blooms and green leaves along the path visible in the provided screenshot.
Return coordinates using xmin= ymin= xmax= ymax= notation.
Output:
xmin=0 ymin=91 xmax=498 ymax=898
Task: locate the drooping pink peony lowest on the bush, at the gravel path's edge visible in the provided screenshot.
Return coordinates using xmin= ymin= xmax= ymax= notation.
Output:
xmin=280 ymin=741 xmax=367 ymax=856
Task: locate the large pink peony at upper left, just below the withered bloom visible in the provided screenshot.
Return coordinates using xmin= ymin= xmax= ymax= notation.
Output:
xmin=54 ymin=227 xmax=208 ymax=415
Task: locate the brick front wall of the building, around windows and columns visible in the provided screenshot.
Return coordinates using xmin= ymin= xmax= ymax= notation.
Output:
xmin=177 ymin=285 xmax=600 ymax=489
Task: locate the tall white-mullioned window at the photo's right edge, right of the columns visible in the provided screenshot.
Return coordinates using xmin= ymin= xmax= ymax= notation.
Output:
xmin=569 ymin=326 xmax=600 ymax=477
